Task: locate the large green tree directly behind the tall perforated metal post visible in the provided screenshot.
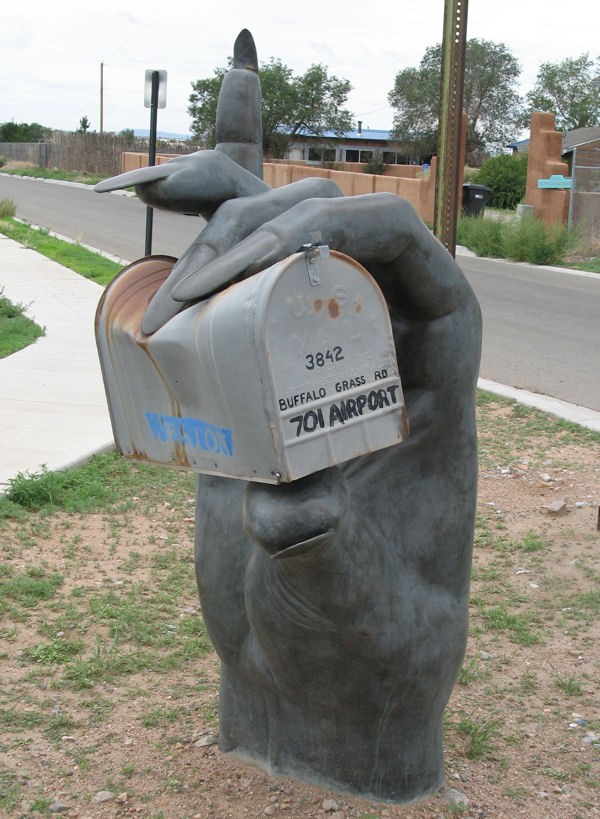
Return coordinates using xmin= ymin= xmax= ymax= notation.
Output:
xmin=388 ymin=38 xmax=522 ymax=156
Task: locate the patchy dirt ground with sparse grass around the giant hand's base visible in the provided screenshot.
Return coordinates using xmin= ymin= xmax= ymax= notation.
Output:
xmin=0 ymin=408 xmax=600 ymax=819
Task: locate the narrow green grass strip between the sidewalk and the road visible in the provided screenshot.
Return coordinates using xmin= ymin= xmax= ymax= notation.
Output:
xmin=0 ymin=219 xmax=122 ymax=285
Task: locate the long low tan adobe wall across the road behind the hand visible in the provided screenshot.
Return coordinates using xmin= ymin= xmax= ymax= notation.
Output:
xmin=121 ymin=153 xmax=440 ymax=223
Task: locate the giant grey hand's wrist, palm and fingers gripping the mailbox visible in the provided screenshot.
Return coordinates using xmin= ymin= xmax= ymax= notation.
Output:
xmin=98 ymin=28 xmax=481 ymax=802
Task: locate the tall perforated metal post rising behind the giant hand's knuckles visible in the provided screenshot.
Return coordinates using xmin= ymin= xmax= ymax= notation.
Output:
xmin=433 ymin=0 xmax=468 ymax=256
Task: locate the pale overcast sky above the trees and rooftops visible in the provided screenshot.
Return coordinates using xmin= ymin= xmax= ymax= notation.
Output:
xmin=0 ymin=0 xmax=600 ymax=134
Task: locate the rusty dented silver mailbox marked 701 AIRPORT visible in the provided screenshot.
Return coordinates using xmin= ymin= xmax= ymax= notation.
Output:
xmin=96 ymin=247 xmax=408 ymax=483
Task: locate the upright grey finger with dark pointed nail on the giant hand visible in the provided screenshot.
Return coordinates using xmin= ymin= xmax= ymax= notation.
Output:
xmin=215 ymin=29 xmax=263 ymax=179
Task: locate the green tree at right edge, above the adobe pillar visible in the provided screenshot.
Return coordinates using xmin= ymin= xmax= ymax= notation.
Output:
xmin=523 ymin=54 xmax=600 ymax=131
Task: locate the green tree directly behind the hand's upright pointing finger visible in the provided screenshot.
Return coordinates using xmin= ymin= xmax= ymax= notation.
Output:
xmin=188 ymin=58 xmax=352 ymax=156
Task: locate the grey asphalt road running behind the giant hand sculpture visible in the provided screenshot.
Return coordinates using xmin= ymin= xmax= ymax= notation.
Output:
xmin=0 ymin=174 xmax=600 ymax=411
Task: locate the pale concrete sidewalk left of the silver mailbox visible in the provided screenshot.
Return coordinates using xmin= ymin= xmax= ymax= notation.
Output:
xmin=0 ymin=234 xmax=114 ymax=492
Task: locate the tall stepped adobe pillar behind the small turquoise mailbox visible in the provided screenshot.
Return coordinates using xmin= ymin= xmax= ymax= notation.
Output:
xmin=524 ymin=111 xmax=570 ymax=225
